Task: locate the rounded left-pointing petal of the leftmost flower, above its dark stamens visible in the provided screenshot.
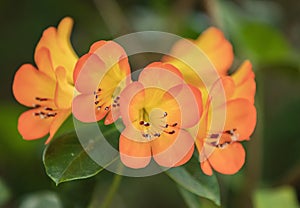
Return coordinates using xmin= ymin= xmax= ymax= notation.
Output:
xmin=13 ymin=64 xmax=55 ymax=107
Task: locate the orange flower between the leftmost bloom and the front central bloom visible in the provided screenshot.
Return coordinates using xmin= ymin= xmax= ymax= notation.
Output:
xmin=73 ymin=41 xmax=131 ymax=124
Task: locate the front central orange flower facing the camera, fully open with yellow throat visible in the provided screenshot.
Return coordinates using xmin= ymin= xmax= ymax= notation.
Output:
xmin=119 ymin=62 xmax=202 ymax=168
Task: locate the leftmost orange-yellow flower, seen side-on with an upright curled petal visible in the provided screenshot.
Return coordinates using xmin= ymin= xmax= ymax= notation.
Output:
xmin=13 ymin=17 xmax=77 ymax=143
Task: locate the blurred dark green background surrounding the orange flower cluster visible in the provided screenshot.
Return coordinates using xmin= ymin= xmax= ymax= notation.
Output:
xmin=0 ymin=0 xmax=300 ymax=208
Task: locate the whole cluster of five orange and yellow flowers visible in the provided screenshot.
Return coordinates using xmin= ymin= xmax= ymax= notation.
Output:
xmin=13 ymin=17 xmax=256 ymax=175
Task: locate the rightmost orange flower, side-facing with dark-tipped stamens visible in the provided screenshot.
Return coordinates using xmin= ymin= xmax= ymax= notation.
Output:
xmin=196 ymin=61 xmax=256 ymax=175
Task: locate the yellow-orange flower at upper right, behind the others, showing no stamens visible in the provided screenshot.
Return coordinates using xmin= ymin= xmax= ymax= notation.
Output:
xmin=162 ymin=27 xmax=234 ymax=88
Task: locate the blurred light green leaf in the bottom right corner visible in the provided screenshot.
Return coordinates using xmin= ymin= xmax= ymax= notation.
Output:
xmin=254 ymin=186 xmax=299 ymax=208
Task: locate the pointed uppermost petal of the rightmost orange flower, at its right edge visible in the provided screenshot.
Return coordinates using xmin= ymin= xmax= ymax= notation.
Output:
xmin=232 ymin=60 xmax=256 ymax=104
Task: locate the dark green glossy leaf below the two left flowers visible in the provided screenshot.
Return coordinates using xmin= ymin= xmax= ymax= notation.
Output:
xmin=43 ymin=118 xmax=120 ymax=185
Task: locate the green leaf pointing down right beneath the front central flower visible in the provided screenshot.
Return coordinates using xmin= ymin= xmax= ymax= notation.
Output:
xmin=166 ymin=159 xmax=220 ymax=206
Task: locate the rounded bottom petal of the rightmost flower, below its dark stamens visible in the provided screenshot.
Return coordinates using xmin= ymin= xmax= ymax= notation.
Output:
xmin=208 ymin=142 xmax=245 ymax=174
